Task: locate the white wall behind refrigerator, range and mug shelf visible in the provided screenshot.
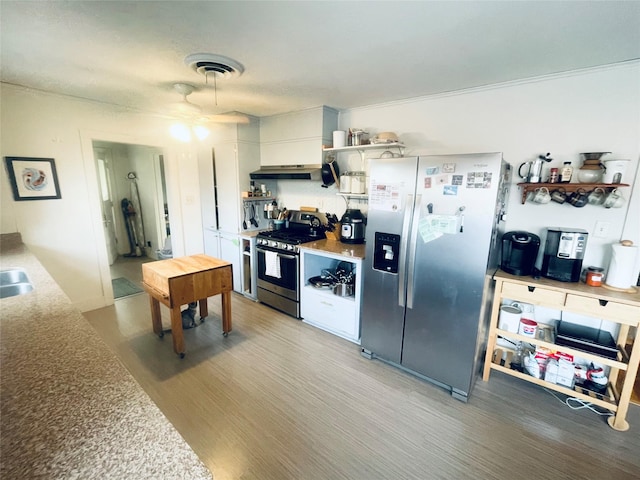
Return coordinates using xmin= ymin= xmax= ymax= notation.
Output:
xmin=278 ymin=62 xmax=640 ymax=280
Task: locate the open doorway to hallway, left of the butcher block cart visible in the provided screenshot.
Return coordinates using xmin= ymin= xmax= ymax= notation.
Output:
xmin=92 ymin=140 xmax=170 ymax=299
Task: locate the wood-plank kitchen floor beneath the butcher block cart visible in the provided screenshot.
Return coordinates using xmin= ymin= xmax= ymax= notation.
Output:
xmin=85 ymin=288 xmax=640 ymax=480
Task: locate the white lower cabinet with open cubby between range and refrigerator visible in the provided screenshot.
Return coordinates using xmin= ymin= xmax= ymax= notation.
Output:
xmin=300 ymin=248 xmax=362 ymax=344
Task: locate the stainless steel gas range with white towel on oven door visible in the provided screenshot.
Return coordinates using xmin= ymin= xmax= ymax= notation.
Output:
xmin=256 ymin=210 xmax=327 ymax=318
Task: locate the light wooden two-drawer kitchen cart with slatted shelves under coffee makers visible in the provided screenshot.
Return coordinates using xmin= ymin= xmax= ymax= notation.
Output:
xmin=483 ymin=271 xmax=640 ymax=431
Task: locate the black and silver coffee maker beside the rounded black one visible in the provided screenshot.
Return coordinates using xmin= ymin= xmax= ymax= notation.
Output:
xmin=541 ymin=227 xmax=589 ymax=282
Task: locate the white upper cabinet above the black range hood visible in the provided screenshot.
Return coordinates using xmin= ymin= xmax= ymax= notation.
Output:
xmin=260 ymin=106 xmax=338 ymax=166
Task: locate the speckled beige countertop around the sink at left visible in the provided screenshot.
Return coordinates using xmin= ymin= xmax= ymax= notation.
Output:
xmin=0 ymin=234 xmax=213 ymax=480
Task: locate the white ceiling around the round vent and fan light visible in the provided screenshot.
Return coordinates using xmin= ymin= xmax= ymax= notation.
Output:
xmin=0 ymin=0 xmax=640 ymax=116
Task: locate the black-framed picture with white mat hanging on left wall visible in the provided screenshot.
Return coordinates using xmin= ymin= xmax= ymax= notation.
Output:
xmin=4 ymin=157 xmax=61 ymax=201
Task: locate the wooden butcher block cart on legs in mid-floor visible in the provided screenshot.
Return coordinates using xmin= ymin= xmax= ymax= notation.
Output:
xmin=142 ymin=255 xmax=233 ymax=358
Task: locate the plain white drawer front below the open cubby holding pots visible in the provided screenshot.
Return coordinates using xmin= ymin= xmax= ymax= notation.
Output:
xmin=300 ymin=293 xmax=358 ymax=338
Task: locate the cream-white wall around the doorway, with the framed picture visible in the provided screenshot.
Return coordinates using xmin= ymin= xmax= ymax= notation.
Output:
xmin=0 ymin=84 xmax=209 ymax=311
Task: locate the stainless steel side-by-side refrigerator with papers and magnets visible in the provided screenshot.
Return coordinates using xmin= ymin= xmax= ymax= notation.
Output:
xmin=361 ymin=153 xmax=510 ymax=401
